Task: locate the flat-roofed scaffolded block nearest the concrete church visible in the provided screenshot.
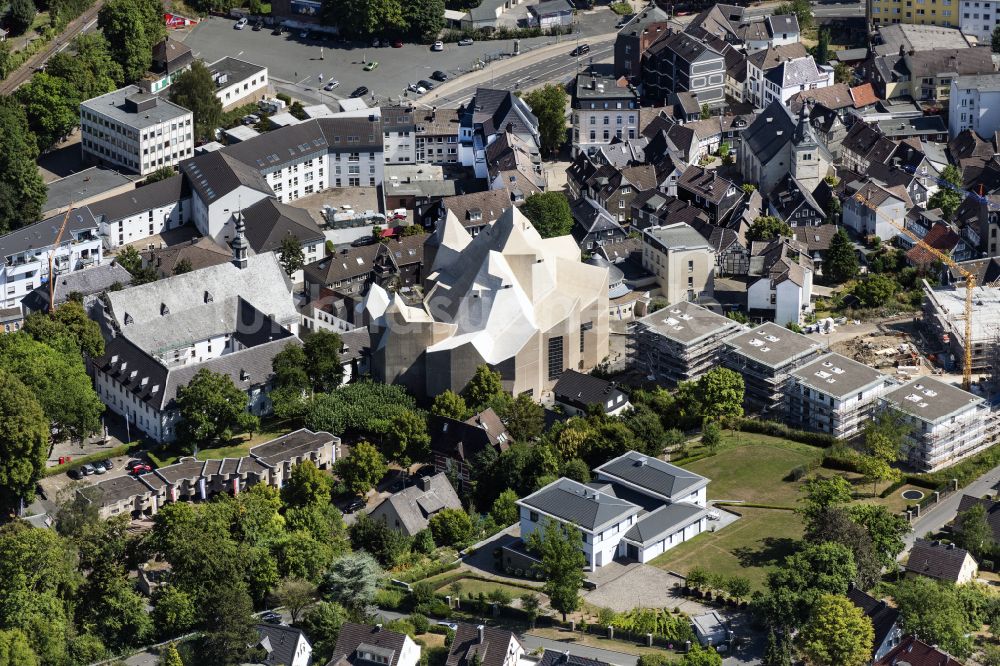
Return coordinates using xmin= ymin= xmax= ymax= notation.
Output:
xmin=632 ymin=301 xmax=742 ymax=386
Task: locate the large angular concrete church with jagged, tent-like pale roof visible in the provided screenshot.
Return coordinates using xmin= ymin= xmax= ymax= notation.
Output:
xmin=369 ymin=207 xmax=609 ymax=399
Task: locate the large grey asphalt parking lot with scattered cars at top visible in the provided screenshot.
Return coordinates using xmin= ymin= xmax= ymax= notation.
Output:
xmin=173 ymin=7 xmax=617 ymax=101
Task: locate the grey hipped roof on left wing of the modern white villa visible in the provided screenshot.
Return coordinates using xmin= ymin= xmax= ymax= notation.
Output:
xmin=518 ymin=478 xmax=641 ymax=532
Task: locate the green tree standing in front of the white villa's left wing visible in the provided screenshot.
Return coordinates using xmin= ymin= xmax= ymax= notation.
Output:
xmin=528 ymin=520 xmax=587 ymax=622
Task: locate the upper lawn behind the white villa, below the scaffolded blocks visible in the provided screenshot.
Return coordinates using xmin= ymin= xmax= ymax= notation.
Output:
xmin=684 ymin=432 xmax=823 ymax=507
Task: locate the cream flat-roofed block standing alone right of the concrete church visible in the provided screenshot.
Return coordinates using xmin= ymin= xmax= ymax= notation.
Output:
xmin=642 ymin=222 xmax=715 ymax=303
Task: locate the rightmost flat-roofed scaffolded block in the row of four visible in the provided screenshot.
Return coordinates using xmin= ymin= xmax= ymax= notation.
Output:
xmin=881 ymin=377 xmax=996 ymax=472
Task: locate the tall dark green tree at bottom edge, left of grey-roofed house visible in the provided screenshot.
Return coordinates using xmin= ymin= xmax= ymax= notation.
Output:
xmin=200 ymin=582 xmax=259 ymax=664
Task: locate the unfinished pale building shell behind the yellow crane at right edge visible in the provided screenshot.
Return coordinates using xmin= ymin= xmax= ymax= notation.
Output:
xmin=924 ymin=280 xmax=1000 ymax=374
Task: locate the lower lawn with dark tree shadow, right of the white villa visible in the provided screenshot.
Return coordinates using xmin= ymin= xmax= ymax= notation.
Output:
xmin=652 ymin=506 xmax=802 ymax=589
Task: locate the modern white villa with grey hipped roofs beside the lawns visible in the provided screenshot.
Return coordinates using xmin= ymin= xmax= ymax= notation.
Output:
xmin=517 ymin=451 xmax=709 ymax=570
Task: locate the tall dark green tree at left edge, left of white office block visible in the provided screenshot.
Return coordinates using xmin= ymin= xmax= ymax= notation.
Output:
xmin=0 ymin=97 xmax=47 ymax=234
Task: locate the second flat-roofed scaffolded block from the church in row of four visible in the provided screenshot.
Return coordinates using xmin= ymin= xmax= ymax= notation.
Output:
xmin=723 ymin=322 xmax=825 ymax=415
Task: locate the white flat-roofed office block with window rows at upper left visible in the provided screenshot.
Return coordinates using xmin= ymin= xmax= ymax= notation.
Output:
xmin=80 ymin=86 xmax=194 ymax=175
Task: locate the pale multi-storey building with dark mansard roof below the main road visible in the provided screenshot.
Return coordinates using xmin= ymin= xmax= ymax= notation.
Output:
xmin=573 ymin=73 xmax=639 ymax=153
